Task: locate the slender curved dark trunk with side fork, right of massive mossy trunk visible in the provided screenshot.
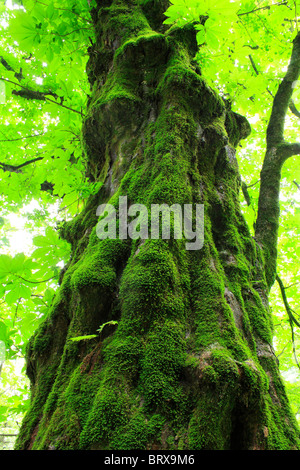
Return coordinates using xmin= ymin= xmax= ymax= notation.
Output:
xmin=255 ymin=33 xmax=300 ymax=289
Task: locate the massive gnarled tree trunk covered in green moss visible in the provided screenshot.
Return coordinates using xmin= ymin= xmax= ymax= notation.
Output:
xmin=16 ymin=0 xmax=299 ymax=450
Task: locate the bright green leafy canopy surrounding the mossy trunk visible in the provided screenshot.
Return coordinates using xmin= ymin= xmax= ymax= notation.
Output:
xmin=0 ymin=0 xmax=300 ymax=440
